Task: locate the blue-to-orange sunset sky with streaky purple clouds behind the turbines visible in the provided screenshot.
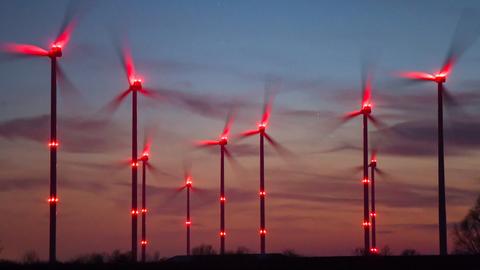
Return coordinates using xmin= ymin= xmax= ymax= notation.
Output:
xmin=0 ymin=0 xmax=480 ymax=260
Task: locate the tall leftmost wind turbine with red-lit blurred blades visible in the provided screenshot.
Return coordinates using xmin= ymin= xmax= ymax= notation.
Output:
xmin=2 ymin=6 xmax=82 ymax=263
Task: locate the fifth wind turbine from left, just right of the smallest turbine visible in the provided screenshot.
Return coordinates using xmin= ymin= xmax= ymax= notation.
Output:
xmin=197 ymin=112 xmax=233 ymax=255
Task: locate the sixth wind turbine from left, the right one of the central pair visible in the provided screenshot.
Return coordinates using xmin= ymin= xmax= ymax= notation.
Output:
xmin=240 ymin=92 xmax=283 ymax=254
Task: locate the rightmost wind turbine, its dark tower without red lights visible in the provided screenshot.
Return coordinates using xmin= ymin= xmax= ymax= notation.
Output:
xmin=399 ymin=11 xmax=480 ymax=255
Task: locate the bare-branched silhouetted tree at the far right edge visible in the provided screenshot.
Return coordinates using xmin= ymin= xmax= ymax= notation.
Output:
xmin=453 ymin=196 xmax=480 ymax=254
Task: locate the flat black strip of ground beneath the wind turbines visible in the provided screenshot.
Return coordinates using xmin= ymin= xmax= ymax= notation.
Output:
xmin=0 ymin=254 xmax=480 ymax=270
